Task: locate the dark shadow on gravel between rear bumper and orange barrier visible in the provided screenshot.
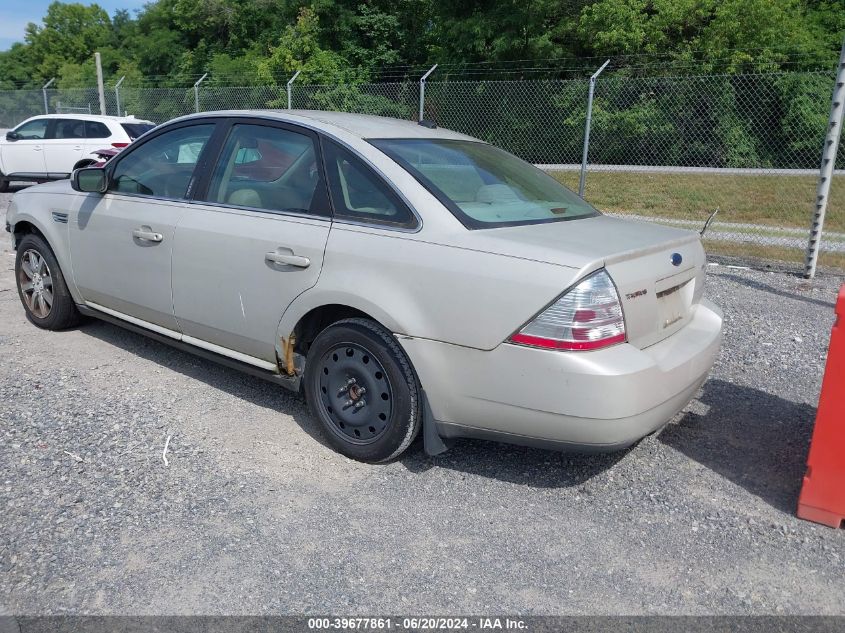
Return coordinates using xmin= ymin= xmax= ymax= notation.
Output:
xmin=659 ymin=379 xmax=816 ymax=514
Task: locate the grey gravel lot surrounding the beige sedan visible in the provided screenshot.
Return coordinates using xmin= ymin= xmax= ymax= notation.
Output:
xmin=0 ymin=186 xmax=845 ymax=614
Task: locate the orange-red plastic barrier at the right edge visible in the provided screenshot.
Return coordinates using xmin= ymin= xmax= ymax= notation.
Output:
xmin=798 ymin=286 xmax=845 ymax=528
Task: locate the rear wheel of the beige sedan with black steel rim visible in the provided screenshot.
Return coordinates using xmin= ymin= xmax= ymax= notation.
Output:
xmin=305 ymin=318 xmax=421 ymax=463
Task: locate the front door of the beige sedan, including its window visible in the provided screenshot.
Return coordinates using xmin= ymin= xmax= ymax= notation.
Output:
xmin=69 ymin=120 xmax=215 ymax=338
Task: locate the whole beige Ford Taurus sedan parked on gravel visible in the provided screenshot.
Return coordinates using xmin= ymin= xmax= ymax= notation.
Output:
xmin=7 ymin=111 xmax=722 ymax=462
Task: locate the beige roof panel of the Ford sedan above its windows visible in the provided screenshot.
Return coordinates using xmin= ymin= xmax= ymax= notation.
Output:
xmin=179 ymin=110 xmax=478 ymax=141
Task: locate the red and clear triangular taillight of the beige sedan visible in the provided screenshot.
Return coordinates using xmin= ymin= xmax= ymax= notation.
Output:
xmin=510 ymin=269 xmax=625 ymax=350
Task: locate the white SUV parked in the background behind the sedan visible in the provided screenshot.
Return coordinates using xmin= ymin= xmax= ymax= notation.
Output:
xmin=0 ymin=114 xmax=155 ymax=191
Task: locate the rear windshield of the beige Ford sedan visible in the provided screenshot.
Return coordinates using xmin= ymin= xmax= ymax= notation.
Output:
xmin=370 ymin=139 xmax=598 ymax=229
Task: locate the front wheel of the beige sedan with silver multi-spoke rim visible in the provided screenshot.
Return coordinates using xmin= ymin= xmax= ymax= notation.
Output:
xmin=15 ymin=234 xmax=80 ymax=330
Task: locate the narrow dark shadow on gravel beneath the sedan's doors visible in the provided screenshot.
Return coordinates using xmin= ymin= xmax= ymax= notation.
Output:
xmin=79 ymin=319 xmax=328 ymax=446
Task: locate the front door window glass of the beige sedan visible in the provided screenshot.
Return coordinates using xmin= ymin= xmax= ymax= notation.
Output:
xmin=109 ymin=124 xmax=214 ymax=198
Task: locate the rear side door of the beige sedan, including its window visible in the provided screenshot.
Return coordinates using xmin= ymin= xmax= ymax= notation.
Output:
xmin=173 ymin=119 xmax=331 ymax=369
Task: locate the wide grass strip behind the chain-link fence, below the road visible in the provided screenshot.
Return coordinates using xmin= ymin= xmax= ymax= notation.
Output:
xmin=551 ymin=171 xmax=845 ymax=232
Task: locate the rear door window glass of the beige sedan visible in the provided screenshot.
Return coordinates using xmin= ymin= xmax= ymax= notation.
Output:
xmin=206 ymin=124 xmax=320 ymax=213
